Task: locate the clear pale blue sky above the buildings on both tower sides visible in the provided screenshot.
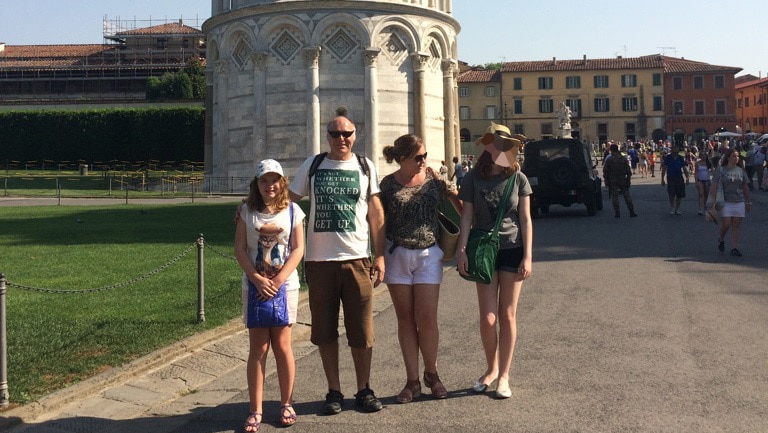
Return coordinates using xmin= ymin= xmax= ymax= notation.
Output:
xmin=0 ymin=0 xmax=768 ymax=77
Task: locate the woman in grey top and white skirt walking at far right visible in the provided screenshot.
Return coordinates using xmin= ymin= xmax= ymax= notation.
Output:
xmin=709 ymin=149 xmax=752 ymax=257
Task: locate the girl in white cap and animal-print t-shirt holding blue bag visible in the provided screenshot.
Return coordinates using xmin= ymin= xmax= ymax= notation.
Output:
xmin=235 ymin=159 xmax=304 ymax=432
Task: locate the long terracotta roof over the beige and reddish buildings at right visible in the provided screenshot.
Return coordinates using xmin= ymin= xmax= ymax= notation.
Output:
xmin=502 ymin=54 xmax=741 ymax=73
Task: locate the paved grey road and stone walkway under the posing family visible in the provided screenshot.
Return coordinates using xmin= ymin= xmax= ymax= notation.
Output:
xmin=0 ymin=177 xmax=768 ymax=433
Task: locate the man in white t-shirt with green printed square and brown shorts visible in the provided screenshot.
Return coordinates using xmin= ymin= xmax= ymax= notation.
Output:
xmin=289 ymin=116 xmax=385 ymax=415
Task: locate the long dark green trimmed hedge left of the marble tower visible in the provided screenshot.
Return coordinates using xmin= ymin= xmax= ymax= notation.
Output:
xmin=0 ymin=107 xmax=205 ymax=164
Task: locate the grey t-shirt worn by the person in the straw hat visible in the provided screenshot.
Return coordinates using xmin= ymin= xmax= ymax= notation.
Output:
xmin=459 ymin=168 xmax=533 ymax=249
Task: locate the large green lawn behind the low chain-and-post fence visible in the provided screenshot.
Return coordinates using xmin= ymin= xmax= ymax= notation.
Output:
xmin=0 ymin=202 xmax=268 ymax=404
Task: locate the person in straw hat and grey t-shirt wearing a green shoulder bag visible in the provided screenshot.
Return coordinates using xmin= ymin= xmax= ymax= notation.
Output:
xmin=457 ymin=123 xmax=533 ymax=398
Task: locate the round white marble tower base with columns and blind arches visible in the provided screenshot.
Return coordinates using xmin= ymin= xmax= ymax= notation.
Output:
xmin=203 ymin=0 xmax=459 ymax=177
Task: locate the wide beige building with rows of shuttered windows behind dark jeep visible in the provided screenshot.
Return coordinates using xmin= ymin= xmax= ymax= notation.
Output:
xmin=502 ymin=56 xmax=664 ymax=143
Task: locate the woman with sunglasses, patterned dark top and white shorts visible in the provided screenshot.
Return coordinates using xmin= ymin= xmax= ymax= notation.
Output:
xmin=380 ymin=135 xmax=461 ymax=403
